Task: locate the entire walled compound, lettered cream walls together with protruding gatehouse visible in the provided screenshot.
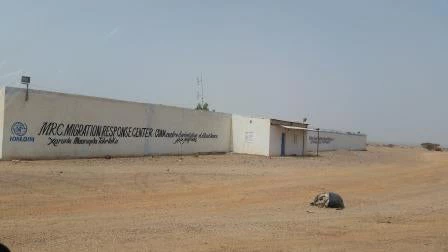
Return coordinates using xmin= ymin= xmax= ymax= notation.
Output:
xmin=0 ymin=87 xmax=366 ymax=160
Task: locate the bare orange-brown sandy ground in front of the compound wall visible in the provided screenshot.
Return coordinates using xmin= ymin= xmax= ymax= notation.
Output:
xmin=0 ymin=147 xmax=448 ymax=251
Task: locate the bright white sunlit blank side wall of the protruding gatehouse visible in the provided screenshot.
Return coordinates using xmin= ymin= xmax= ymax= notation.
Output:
xmin=232 ymin=115 xmax=271 ymax=156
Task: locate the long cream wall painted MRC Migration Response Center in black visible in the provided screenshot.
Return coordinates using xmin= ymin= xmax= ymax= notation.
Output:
xmin=0 ymin=87 xmax=232 ymax=159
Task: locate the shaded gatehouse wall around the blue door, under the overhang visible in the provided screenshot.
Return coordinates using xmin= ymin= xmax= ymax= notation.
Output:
xmin=269 ymin=125 xmax=306 ymax=156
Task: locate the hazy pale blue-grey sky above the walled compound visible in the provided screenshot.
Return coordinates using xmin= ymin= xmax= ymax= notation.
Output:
xmin=0 ymin=0 xmax=448 ymax=145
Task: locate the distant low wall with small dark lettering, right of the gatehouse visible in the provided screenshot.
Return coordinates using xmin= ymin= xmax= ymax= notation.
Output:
xmin=306 ymin=131 xmax=367 ymax=152
